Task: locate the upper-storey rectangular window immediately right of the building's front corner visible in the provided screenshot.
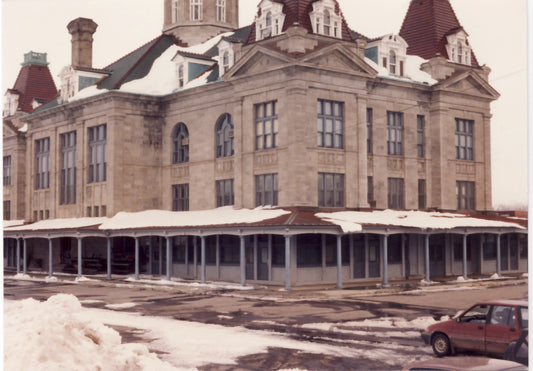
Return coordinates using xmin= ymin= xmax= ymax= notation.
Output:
xmin=317 ymin=99 xmax=344 ymax=148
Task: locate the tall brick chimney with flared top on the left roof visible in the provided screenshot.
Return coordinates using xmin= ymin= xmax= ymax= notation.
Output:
xmin=67 ymin=18 xmax=98 ymax=68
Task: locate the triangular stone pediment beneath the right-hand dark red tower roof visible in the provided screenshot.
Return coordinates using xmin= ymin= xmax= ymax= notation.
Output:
xmin=436 ymin=71 xmax=500 ymax=99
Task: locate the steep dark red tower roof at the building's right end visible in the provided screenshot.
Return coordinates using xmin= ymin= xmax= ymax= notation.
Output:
xmin=400 ymin=0 xmax=479 ymax=67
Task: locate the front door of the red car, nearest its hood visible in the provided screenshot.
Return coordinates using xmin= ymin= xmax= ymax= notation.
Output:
xmin=450 ymin=304 xmax=490 ymax=352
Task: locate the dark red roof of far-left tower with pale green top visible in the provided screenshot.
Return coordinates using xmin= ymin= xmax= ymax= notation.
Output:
xmin=10 ymin=64 xmax=57 ymax=113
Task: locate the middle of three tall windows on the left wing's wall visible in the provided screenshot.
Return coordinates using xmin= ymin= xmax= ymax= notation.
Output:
xmin=59 ymin=131 xmax=76 ymax=205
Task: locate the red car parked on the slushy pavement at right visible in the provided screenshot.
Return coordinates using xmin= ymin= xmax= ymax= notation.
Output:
xmin=422 ymin=300 xmax=528 ymax=357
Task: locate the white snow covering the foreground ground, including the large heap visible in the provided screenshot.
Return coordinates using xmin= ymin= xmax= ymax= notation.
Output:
xmin=4 ymin=294 xmax=432 ymax=371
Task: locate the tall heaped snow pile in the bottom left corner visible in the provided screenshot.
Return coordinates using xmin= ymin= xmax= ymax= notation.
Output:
xmin=4 ymin=294 xmax=174 ymax=371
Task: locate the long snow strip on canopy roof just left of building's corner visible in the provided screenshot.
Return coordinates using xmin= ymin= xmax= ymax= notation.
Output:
xmin=99 ymin=206 xmax=290 ymax=230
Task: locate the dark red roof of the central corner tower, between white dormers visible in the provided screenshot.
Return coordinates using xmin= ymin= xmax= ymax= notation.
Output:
xmin=247 ymin=0 xmax=355 ymax=44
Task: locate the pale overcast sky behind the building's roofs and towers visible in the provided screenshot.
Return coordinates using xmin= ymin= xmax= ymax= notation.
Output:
xmin=2 ymin=0 xmax=528 ymax=207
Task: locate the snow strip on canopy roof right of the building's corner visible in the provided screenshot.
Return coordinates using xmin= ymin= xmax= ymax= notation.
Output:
xmin=315 ymin=210 xmax=526 ymax=233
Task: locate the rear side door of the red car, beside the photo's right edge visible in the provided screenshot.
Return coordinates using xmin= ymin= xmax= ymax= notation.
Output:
xmin=485 ymin=305 xmax=520 ymax=355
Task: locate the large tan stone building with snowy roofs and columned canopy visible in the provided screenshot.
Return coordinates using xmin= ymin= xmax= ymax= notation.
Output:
xmin=4 ymin=0 xmax=527 ymax=287
